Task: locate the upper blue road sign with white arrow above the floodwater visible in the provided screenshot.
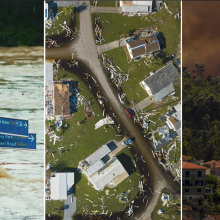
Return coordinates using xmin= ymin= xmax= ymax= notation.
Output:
xmin=0 ymin=117 xmax=28 ymax=137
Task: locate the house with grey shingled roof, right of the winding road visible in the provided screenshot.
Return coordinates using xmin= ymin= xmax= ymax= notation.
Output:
xmin=140 ymin=63 xmax=180 ymax=102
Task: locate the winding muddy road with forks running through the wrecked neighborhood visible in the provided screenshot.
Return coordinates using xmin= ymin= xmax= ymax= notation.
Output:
xmin=46 ymin=2 xmax=180 ymax=220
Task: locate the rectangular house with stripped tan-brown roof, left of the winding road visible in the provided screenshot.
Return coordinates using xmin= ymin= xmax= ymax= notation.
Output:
xmin=54 ymin=83 xmax=69 ymax=116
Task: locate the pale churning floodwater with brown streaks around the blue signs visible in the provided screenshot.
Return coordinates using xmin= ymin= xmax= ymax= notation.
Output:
xmin=0 ymin=47 xmax=44 ymax=220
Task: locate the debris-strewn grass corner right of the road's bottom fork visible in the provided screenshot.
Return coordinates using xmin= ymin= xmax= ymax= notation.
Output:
xmin=153 ymin=189 xmax=181 ymax=220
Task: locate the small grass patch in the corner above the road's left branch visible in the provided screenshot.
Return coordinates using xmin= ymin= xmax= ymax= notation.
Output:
xmin=45 ymin=7 xmax=72 ymax=37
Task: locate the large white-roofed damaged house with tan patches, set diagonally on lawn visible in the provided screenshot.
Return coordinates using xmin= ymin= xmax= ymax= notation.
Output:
xmin=79 ymin=145 xmax=129 ymax=191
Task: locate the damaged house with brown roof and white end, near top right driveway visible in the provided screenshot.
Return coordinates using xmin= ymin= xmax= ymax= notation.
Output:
xmin=126 ymin=34 xmax=160 ymax=59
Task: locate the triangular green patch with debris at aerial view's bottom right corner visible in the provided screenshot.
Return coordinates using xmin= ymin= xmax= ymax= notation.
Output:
xmin=152 ymin=189 xmax=181 ymax=220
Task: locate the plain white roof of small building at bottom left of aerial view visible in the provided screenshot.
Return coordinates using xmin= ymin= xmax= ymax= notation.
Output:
xmin=50 ymin=172 xmax=74 ymax=200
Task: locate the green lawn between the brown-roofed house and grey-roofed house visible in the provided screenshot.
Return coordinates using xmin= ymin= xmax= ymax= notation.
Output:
xmin=100 ymin=48 xmax=168 ymax=104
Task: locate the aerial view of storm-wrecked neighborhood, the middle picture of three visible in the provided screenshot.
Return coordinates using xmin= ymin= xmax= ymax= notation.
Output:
xmin=44 ymin=0 xmax=181 ymax=220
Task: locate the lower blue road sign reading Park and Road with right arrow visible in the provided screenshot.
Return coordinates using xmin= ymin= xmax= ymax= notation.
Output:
xmin=0 ymin=134 xmax=36 ymax=149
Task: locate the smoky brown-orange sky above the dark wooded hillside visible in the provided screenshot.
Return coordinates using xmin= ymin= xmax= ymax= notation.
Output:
xmin=182 ymin=1 xmax=220 ymax=77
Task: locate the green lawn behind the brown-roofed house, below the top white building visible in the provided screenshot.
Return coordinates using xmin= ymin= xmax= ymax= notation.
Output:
xmin=91 ymin=1 xmax=181 ymax=54
